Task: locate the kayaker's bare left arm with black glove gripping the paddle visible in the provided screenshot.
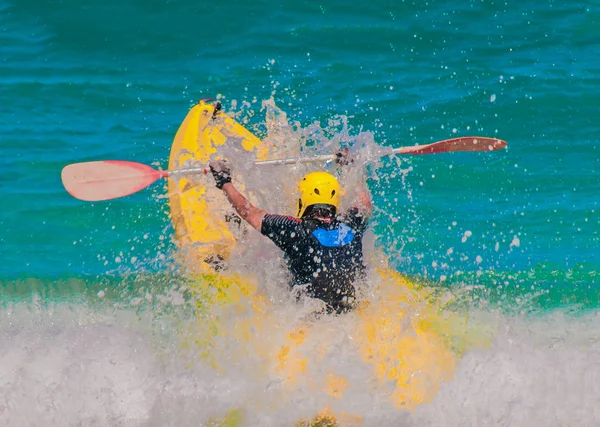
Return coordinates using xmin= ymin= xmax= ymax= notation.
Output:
xmin=209 ymin=160 xmax=266 ymax=231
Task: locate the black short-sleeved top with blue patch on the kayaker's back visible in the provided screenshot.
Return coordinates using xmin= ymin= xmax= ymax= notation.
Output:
xmin=261 ymin=209 xmax=367 ymax=312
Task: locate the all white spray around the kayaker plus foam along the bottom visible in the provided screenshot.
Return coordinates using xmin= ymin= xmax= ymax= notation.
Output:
xmin=0 ymin=101 xmax=600 ymax=426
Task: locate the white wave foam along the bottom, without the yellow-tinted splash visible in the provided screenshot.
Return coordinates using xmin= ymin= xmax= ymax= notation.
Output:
xmin=0 ymin=304 xmax=600 ymax=427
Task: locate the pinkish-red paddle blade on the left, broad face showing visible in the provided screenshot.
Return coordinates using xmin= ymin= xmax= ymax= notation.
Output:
xmin=61 ymin=160 xmax=168 ymax=202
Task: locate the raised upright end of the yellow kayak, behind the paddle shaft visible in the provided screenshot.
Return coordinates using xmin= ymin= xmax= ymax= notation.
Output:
xmin=169 ymin=101 xmax=262 ymax=273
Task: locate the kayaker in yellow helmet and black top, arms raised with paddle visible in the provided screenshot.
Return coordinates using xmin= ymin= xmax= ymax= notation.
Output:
xmin=210 ymin=150 xmax=372 ymax=313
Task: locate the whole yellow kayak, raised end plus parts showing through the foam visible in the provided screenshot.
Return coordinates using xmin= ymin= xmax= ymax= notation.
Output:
xmin=168 ymin=101 xmax=490 ymax=425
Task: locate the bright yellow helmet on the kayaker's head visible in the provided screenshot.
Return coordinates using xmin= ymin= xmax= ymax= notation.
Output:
xmin=298 ymin=172 xmax=340 ymax=218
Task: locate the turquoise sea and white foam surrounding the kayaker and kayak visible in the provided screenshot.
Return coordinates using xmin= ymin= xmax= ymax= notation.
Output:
xmin=0 ymin=0 xmax=600 ymax=426
